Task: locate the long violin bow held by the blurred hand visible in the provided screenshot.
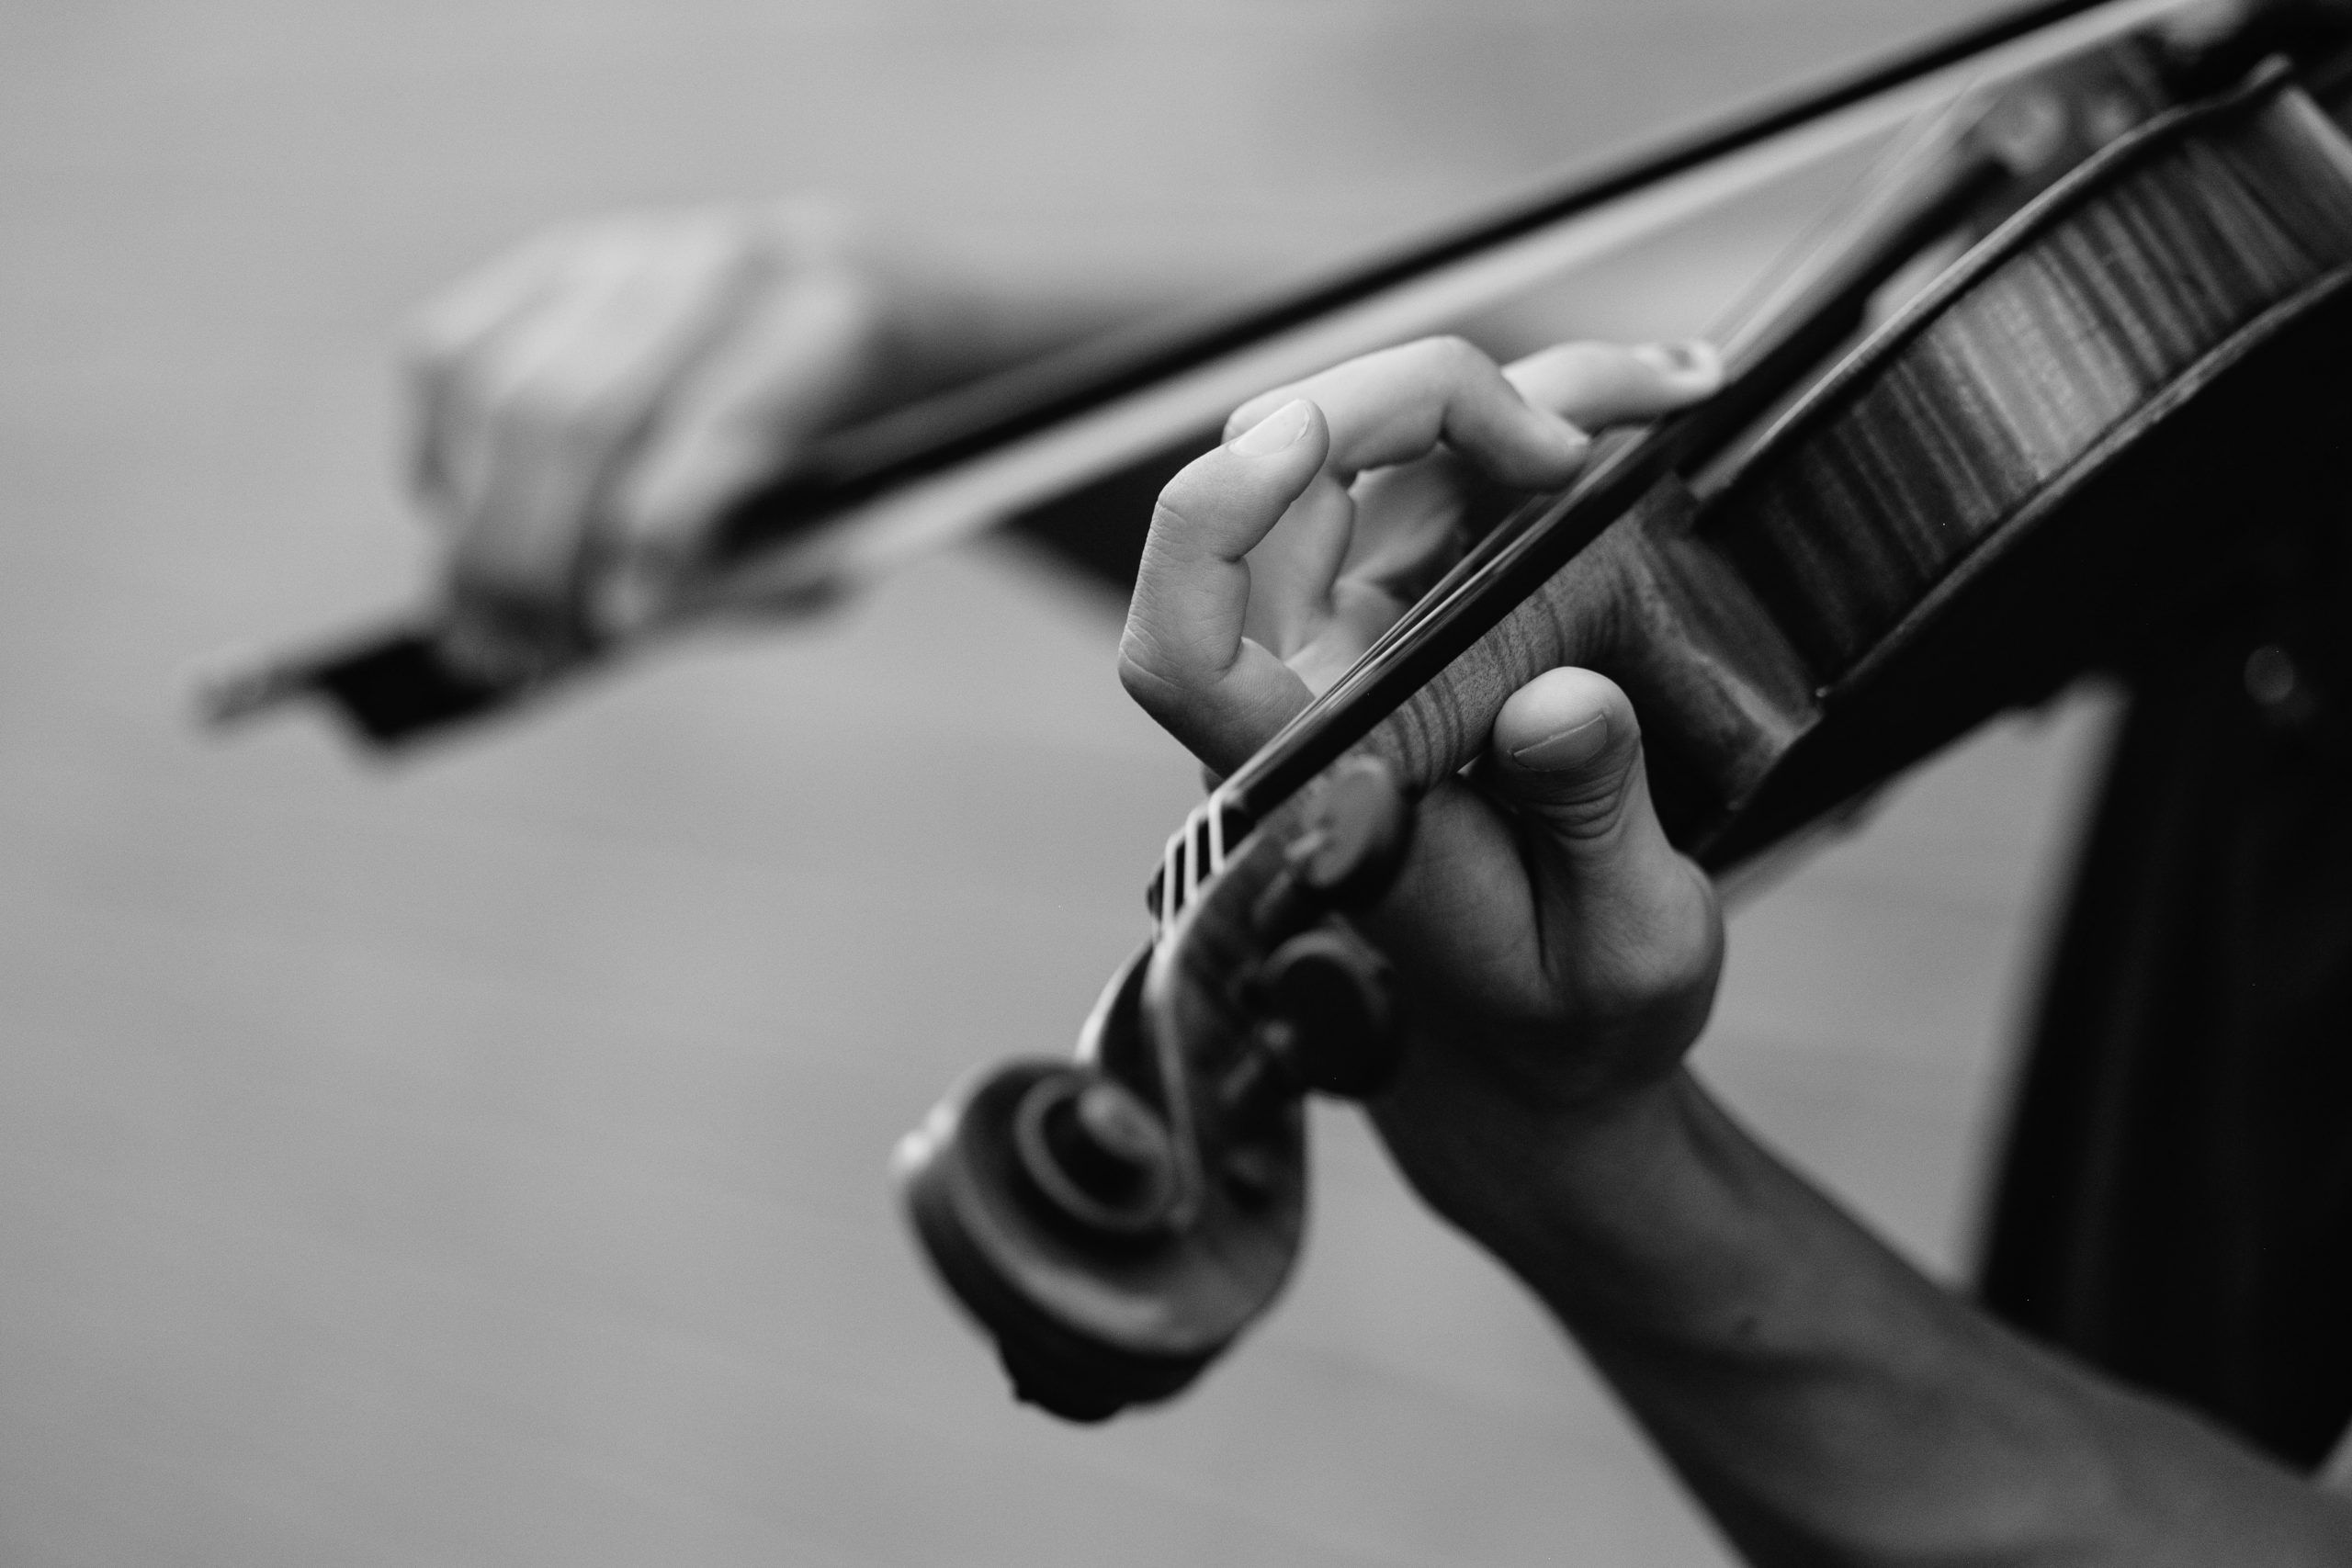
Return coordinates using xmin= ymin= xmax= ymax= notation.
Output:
xmin=198 ymin=0 xmax=2180 ymax=748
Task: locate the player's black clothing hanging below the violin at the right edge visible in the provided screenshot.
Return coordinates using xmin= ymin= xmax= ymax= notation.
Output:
xmin=1983 ymin=573 xmax=2352 ymax=1467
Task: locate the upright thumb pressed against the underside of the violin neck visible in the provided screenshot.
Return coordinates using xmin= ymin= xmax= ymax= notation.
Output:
xmin=1488 ymin=670 xmax=1722 ymax=1018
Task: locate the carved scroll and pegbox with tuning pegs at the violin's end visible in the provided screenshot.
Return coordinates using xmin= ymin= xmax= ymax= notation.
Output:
xmin=896 ymin=760 xmax=1411 ymax=1420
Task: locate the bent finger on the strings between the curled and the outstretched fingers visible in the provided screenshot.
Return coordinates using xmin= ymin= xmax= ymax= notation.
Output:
xmin=1226 ymin=339 xmax=1590 ymax=489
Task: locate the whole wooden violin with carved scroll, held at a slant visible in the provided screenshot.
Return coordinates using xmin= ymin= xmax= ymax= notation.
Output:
xmin=899 ymin=38 xmax=2352 ymax=1420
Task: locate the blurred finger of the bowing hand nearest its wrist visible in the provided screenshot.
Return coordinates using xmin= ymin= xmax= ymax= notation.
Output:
xmin=609 ymin=270 xmax=879 ymax=614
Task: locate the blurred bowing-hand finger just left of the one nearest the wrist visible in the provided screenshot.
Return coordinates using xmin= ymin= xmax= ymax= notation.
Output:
xmin=452 ymin=226 xmax=746 ymax=639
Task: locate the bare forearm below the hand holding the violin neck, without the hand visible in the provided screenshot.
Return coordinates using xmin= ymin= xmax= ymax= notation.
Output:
xmin=1374 ymin=1075 xmax=2352 ymax=1563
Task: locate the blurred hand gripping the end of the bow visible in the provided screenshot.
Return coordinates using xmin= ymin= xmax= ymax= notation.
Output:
xmin=407 ymin=200 xmax=1126 ymax=668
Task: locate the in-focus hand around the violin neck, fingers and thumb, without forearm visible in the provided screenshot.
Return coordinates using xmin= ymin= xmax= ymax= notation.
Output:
xmin=1120 ymin=339 xmax=1722 ymax=1229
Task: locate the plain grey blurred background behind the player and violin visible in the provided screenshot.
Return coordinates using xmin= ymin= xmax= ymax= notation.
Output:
xmin=0 ymin=0 xmax=2105 ymax=1568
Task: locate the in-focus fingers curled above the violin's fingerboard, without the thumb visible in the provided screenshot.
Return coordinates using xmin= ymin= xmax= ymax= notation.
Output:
xmin=1120 ymin=339 xmax=1719 ymax=773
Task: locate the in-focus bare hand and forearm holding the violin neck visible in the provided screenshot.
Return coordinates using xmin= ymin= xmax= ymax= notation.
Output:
xmin=1122 ymin=344 xmax=2352 ymax=1568
